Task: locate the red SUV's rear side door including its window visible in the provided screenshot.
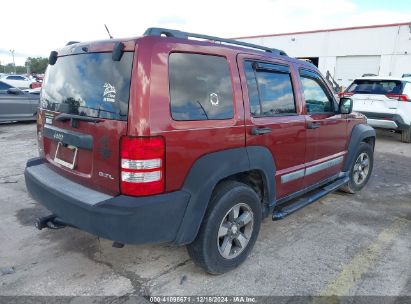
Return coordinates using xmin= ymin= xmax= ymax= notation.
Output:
xmin=237 ymin=55 xmax=306 ymax=200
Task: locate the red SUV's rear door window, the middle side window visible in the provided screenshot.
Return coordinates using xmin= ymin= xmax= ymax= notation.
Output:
xmin=245 ymin=61 xmax=296 ymax=117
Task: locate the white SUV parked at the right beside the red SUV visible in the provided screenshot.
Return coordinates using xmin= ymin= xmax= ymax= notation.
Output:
xmin=340 ymin=76 xmax=411 ymax=143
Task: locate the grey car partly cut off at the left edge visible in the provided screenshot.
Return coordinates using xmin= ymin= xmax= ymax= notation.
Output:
xmin=0 ymin=81 xmax=40 ymax=122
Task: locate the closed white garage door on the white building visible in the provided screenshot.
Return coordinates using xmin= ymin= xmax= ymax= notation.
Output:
xmin=334 ymin=56 xmax=380 ymax=87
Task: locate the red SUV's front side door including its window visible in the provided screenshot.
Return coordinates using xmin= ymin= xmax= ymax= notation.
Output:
xmin=300 ymin=70 xmax=347 ymax=187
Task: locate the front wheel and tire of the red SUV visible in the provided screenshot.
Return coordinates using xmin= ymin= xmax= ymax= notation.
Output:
xmin=340 ymin=142 xmax=374 ymax=193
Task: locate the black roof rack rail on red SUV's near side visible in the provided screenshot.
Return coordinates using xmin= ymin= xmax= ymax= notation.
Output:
xmin=144 ymin=27 xmax=287 ymax=56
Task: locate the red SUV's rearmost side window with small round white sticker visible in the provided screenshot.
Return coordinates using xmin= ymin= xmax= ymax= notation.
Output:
xmin=169 ymin=53 xmax=234 ymax=120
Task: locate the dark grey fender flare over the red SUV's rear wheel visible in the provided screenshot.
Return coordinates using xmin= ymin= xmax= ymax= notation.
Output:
xmin=174 ymin=146 xmax=275 ymax=245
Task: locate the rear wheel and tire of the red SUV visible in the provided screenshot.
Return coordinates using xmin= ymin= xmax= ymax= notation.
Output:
xmin=187 ymin=181 xmax=262 ymax=274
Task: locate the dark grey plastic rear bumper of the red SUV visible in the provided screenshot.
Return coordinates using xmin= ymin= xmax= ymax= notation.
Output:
xmin=24 ymin=158 xmax=190 ymax=244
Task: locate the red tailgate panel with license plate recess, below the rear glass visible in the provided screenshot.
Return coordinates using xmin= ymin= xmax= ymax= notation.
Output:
xmin=42 ymin=111 xmax=127 ymax=195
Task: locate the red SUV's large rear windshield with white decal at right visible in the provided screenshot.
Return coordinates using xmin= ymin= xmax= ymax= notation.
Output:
xmin=40 ymin=52 xmax=133 ymax=120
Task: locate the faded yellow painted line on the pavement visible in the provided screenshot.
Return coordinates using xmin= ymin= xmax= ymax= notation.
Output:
xmin=320 ymin=218 xmax=410 ymax=296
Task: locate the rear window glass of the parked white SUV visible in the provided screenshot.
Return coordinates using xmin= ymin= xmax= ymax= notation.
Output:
xmin=347 ymin=79 xmax=402 ymax=95
